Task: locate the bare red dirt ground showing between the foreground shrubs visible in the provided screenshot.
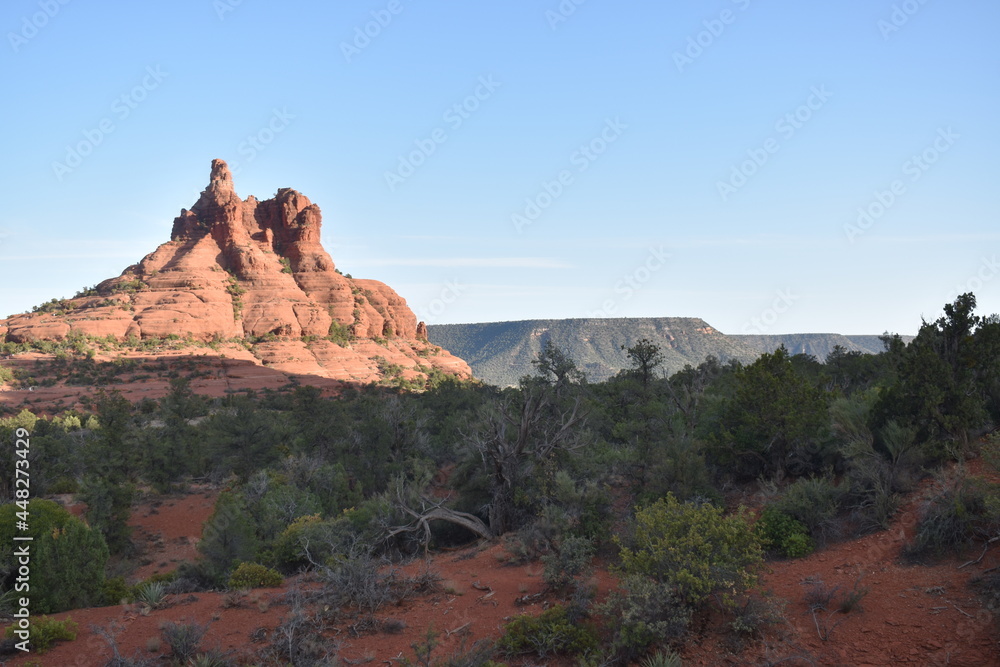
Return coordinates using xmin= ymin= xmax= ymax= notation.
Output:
xmin=5 ymin=467 xmax=1000 ymax=667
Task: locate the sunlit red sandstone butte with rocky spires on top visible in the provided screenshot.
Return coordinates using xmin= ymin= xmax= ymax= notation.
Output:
xmin=0 ymin=160 xmax=471 ymax=382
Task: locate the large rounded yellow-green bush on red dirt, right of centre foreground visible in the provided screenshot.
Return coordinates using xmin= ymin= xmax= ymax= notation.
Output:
xmin=615 ymin=494 xmax=762 ymax=607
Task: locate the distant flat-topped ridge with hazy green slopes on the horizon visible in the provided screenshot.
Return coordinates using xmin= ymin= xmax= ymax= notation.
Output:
xmin=427 ymin=317 xmax=904 ymax=386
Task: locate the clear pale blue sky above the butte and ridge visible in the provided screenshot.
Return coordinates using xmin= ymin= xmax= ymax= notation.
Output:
xmin=0 ymin=0 xmax=1000 ymax=333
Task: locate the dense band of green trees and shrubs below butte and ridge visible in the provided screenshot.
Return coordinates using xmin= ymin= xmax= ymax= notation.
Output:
xmin=0 ymin=294 xmax=1000 ymax=665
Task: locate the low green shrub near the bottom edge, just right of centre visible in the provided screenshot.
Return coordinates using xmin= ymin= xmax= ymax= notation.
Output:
xmin=497 ymin=605 xmax=598 ymax=658
